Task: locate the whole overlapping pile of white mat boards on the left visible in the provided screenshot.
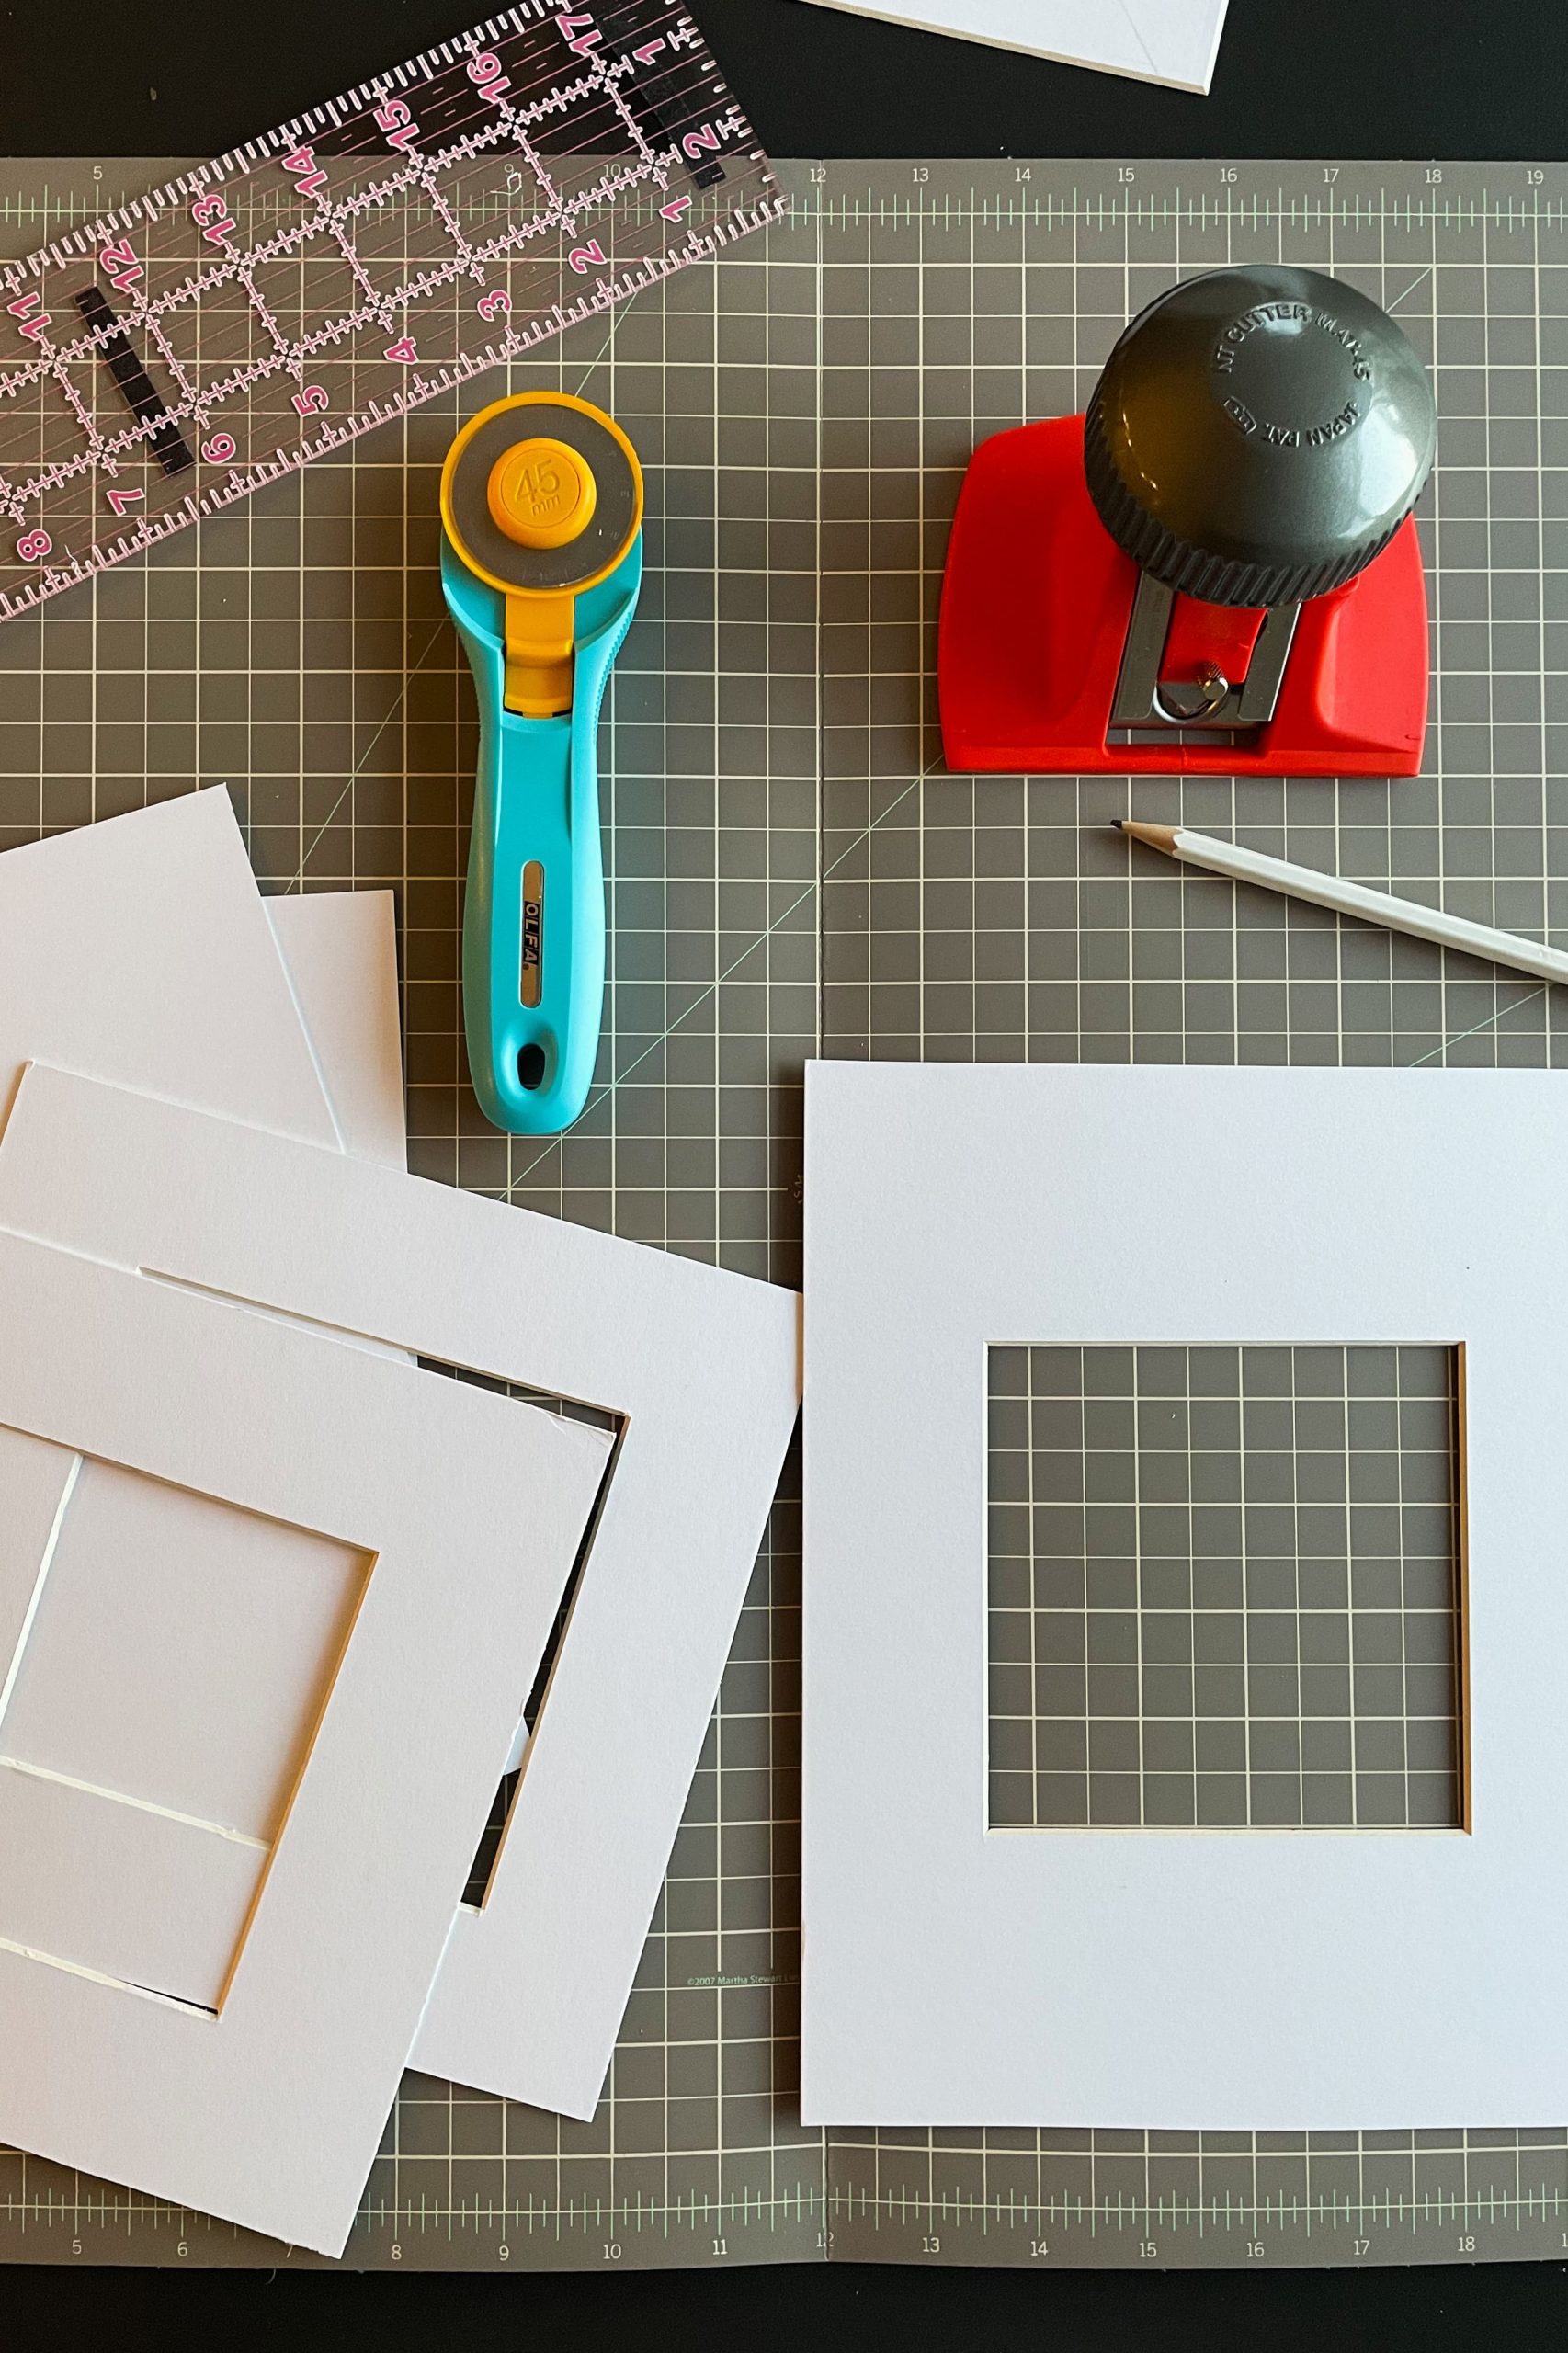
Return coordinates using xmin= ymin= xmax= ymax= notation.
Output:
xmin=0 ymin=790 xmax=798 ymax=2252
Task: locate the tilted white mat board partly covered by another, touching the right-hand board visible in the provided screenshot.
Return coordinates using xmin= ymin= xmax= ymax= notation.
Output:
xmin=0 ymin=1068 xmax=801 ymax=2115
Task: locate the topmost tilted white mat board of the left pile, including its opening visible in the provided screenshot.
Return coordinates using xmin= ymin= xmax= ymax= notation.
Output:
xmin=0 ymin=1223 xmax=608 ymax=2254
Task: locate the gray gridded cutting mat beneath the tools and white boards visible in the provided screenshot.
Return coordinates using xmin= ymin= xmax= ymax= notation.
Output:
xmin=0 ymin=160 xmax=1568 ymax=2270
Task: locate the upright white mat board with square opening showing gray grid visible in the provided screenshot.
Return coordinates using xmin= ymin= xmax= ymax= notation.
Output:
xmin=802 ymin=1063 xmax=1568 ymax=2130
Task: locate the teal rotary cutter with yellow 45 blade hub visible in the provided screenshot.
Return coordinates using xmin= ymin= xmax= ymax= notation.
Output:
xmin=440 ymin=393 xmax=642 ymax=1136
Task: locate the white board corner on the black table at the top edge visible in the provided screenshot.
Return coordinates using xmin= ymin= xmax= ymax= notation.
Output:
xmin=795 ymin=0 xmax=1229 ymax=92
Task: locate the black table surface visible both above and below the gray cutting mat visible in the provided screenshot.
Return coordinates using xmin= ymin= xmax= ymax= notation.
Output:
xmin=0 ymin=0 xmax=1568 ymax=2353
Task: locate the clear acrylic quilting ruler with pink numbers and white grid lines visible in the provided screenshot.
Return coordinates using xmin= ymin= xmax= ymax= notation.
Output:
xmin=0 ymin=0 xmax=784 ymax=619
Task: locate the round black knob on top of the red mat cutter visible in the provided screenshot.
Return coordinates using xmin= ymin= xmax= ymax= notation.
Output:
xmin=1083 ymin=266 xmax=1437 ymax=605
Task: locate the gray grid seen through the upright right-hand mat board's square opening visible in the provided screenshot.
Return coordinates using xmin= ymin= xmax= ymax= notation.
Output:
xmin=986 ymin=1346 xmax=1462 ymax=1831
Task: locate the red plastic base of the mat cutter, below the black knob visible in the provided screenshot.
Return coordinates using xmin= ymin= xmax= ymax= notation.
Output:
xmin=937 ymin=416 xmax=1429 ymax=777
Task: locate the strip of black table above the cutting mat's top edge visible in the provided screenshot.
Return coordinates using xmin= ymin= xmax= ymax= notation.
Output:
xmin=0 ymin=0 xmax=1568 ymax=163
